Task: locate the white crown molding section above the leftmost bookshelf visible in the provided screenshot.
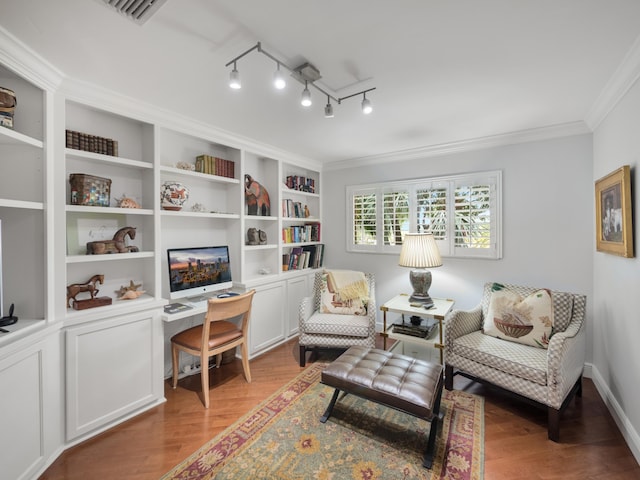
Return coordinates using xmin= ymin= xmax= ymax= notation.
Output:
xmin=0 ymin=27 xmax=65 ymax=90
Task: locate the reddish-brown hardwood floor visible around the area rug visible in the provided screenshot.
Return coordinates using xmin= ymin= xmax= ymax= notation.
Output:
xmin=40 ymin=339 xmax=640 ymax=480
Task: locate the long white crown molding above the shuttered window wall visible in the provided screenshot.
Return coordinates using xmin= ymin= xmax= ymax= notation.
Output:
xmin=323 ymin=121 xmax=591 ymax=170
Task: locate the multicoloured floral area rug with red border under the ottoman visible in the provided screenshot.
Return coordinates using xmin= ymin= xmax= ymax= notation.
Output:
xmin=162 ymin=363 xmax=484 ymax=480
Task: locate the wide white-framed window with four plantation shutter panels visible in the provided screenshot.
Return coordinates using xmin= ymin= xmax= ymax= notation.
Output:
xmin=347 ymin=171 xmax=502 ymax=258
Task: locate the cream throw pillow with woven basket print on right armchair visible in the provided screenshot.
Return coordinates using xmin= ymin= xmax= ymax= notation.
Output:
xmin=483 ymin=284 xmax=553 ymax=348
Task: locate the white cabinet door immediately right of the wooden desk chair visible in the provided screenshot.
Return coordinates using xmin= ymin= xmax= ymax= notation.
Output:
xmin=249 ymin=282 xmax=286 ymax=356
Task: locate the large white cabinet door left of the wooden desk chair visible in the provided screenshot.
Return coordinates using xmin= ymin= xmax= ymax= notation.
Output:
xmin=66 ymin=311 xmax=163 ymax=440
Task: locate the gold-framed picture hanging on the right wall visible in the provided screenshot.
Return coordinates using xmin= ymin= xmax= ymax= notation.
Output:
xmin=595 ymin=165 xmax=634 ymax=258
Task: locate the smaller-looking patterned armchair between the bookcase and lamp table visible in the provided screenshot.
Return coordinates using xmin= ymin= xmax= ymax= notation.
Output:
xmin=298 ymin=272 xmax=376 ymax=367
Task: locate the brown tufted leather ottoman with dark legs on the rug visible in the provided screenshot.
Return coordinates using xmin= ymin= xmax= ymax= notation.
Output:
xmin=320 ymin=346 xmax=443 ymax=468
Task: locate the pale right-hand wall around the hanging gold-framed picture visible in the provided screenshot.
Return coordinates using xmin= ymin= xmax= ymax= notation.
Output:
xmin=592 ymin=78 xmax=640 ymax=459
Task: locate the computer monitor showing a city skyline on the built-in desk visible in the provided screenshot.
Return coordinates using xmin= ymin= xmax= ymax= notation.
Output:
xmin=167 ymin=245 xmax=233 ymax=301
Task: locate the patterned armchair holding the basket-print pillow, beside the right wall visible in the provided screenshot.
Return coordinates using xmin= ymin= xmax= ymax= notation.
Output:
xmin=445 ymin=283 xmax=586 ymax=442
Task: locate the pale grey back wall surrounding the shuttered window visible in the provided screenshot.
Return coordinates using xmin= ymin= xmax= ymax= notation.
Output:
xmin=322 ymin=135 xmax=594 ymax=359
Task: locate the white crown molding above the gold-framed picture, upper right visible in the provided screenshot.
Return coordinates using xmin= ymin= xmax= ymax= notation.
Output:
xmin=585 ymin=32 xmax=640 ymax=131
